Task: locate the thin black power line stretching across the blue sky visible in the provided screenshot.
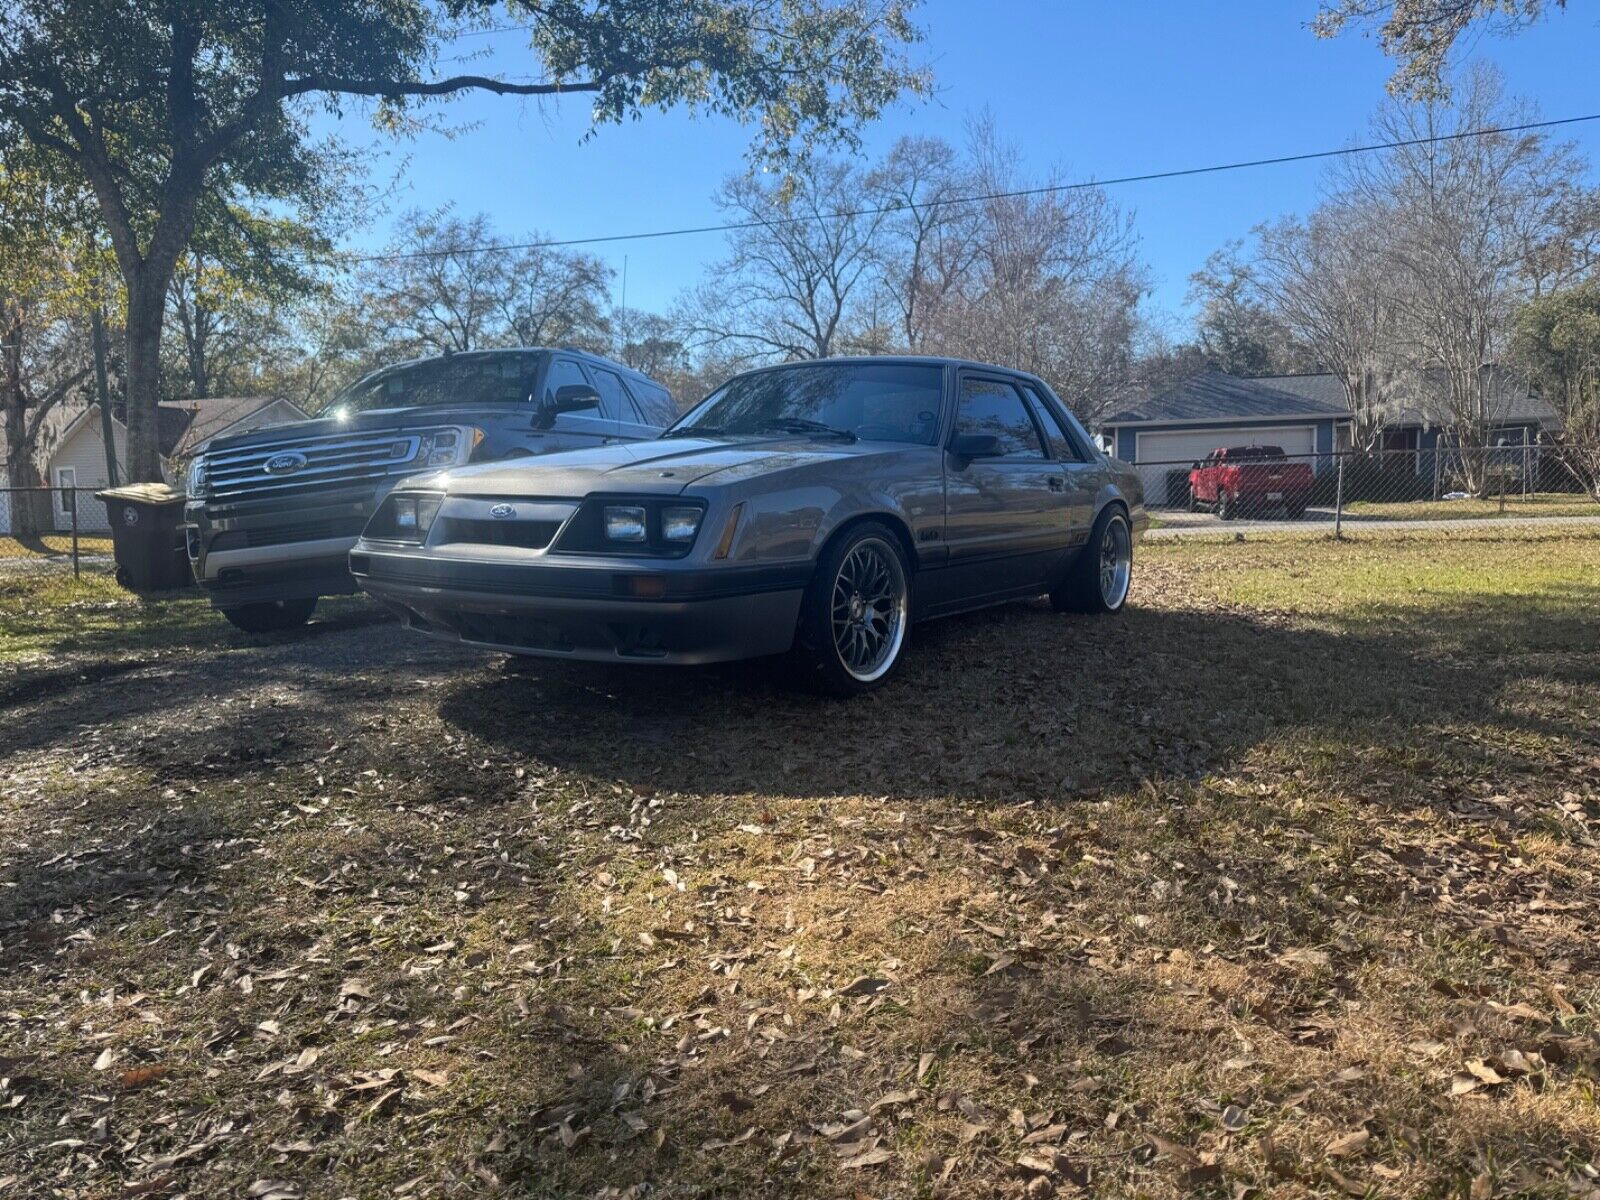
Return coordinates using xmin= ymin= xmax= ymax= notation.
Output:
xmin=302 ymin=112 xmax=1600 ymax=266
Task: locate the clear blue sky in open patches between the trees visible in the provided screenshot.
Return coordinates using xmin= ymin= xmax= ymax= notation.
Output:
xmin=308 ymin=0 xmax=1600 ymax=333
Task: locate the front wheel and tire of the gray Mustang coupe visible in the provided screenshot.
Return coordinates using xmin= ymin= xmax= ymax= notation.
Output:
xmin=795 ymin=522 xmax=910 ymax=696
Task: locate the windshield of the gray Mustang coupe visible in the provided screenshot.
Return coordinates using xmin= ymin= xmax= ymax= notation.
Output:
xmin=669 ymin=363 xmax=944 ymax=445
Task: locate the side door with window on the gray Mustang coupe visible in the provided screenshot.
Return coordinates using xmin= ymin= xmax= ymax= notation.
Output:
xmin=944 ymin=371 xmax=1072 ymax=603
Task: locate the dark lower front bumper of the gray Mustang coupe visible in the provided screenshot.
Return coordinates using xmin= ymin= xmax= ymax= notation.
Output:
xmin=350 ymin=541 xmax=811 ymax=666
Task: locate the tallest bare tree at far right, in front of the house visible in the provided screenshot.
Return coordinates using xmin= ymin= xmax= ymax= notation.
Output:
xmin=1344 ymin=69 xmax=1584 ymax=491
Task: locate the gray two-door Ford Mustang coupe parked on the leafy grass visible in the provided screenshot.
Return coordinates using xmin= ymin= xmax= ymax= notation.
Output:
xmin=350 ymin=357 xmax=1149 ymax=694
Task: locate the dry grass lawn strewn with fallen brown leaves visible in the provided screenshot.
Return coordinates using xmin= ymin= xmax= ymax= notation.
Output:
xmin=0 ymin=530 xmax=1600 ymax=1200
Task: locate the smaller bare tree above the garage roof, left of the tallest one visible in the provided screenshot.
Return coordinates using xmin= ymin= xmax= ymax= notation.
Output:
xmin=1254 ymin=198 xmax=1398 ymax=450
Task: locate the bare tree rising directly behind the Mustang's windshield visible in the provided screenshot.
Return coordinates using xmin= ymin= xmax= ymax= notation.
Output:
xmin=682 ymin=158 xmax=883 ymax=362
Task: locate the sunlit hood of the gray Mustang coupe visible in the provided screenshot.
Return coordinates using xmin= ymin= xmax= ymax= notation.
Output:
xmin=432 ymin=435 xmax=906 ymax=499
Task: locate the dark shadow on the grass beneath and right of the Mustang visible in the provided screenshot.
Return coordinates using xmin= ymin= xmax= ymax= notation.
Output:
xmin=440 ymin=589 xmax=1600 ymax=802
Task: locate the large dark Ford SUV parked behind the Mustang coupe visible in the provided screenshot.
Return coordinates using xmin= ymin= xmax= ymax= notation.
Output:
xmin=184 ymin=349 xmax=677 ymax=634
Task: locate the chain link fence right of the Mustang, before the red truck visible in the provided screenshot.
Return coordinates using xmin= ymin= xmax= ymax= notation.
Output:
xmin=1134 ymin=443 xmax=1600 ymax=534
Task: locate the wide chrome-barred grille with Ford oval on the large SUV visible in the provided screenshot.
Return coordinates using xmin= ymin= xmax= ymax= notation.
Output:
xmin=205 ymin=432 xmax=435 ymax=504
